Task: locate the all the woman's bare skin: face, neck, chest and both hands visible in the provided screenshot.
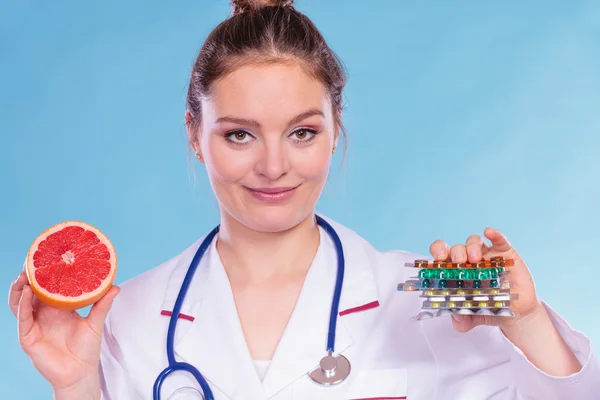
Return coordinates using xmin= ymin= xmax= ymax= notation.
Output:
xmin=9 ymin=63 xmax=581 ymax=400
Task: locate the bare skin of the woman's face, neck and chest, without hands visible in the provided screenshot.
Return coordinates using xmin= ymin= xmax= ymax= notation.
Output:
xmin=192 ymin=64 xmax=338 ymax=360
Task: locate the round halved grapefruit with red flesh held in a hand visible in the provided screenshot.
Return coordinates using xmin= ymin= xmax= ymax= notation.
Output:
xmin=25 ymin=221 xmax=117 ymax=310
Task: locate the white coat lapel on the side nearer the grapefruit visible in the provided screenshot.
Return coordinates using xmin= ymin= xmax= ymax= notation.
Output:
xmin=159 ymin=239 xmax=264 ymax=399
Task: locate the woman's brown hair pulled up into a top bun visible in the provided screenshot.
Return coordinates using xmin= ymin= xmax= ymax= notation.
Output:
xmin=187 ymin=0 xmax=346 ymax=152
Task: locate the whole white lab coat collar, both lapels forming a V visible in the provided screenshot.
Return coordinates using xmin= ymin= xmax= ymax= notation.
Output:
xmin=163 ymin=217 xmax=379 ymax=399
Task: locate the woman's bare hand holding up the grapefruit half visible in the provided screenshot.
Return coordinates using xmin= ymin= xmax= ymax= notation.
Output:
xmin=8 ymin=272 xmax=119 ymax=397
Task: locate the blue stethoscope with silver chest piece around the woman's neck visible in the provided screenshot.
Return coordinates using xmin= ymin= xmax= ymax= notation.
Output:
xmin=153 ymin=215 xmax=350 ymax=400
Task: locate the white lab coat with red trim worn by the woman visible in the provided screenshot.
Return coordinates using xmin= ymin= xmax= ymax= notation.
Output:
xmin=101 ymin=217 xmax=600 ymax=400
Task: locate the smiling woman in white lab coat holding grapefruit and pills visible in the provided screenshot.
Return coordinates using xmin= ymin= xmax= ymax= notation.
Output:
xmin=10 ymin=0 xmax=600 ymax=400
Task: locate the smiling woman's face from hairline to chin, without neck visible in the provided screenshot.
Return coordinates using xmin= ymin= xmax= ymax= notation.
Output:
xmin=193 ymin=64 xmax=338 ymax=232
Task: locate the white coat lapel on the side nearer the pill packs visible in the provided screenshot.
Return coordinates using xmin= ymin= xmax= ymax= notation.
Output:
xmin=263 ymin=217 xmax=378 ymax=398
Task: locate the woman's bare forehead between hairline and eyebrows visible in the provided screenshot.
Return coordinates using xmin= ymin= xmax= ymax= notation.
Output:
xmin=207 ymin=63 xmax=331 ymax=118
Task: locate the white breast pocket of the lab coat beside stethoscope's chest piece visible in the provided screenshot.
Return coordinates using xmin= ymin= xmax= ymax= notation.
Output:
xmin=344 ymin=368 xmax=407 ymax=400
